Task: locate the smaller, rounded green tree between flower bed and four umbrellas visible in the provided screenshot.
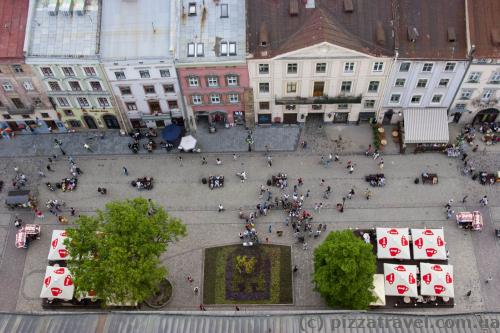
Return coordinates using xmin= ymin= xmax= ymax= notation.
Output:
xmin=313 ymin=230 xmax=376 ymax=310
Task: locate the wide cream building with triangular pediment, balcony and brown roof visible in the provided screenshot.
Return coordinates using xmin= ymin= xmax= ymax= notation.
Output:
xmin=247 ymin=0 xmax=394 ymax=124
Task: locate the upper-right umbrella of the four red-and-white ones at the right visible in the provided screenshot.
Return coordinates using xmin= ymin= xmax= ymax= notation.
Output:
xmin=411 ymin=229 xmax=446 ymax=260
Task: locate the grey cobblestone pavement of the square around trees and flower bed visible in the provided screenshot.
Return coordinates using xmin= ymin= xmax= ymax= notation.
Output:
xmin=0 ymin=148 xmax=500 ymax=313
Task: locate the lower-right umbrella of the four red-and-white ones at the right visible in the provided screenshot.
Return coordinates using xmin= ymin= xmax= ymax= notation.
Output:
xmin=420 ymin=262 xmax=455 ymax=297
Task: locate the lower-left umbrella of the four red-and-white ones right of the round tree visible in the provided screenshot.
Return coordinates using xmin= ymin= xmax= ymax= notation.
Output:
xmin=384 ymin=264 xmax=418 ymax=297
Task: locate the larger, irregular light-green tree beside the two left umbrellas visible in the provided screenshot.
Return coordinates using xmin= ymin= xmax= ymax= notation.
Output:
xmin=65 ymin=198 xmax=186 ymax=303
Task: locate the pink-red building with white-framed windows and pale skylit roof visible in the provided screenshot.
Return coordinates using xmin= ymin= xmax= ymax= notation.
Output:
xmin=176 ymin=0 xmax=249 ymax=129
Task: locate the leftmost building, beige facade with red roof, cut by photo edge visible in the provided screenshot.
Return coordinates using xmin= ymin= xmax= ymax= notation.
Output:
xmin=0 ymin=0 xmax=60 ymax=133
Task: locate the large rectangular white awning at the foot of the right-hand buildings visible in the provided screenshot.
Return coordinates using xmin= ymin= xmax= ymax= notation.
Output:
xmin=403 ymin=108 xmax=450 ymax=143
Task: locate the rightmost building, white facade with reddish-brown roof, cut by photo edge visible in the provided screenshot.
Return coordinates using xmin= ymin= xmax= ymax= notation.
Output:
xmin=450 ymin=0 xmax=500 ymax=123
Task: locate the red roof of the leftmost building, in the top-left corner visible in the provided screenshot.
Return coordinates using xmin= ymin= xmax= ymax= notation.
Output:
xmin=0 ymin=0 xmax=29 ymax=60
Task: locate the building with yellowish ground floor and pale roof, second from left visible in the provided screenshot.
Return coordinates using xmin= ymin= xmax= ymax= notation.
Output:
xmin=26 ymin=0 xmax=123 ymax=129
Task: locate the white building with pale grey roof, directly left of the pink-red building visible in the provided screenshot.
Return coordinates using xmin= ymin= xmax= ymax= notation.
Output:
xmin=100 ymin=0 xmax=184 ymax=128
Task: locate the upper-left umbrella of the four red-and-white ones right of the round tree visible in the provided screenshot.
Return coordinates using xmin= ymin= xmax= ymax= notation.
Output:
xmin=377 ymin=228 xmax=410 ymax=259
